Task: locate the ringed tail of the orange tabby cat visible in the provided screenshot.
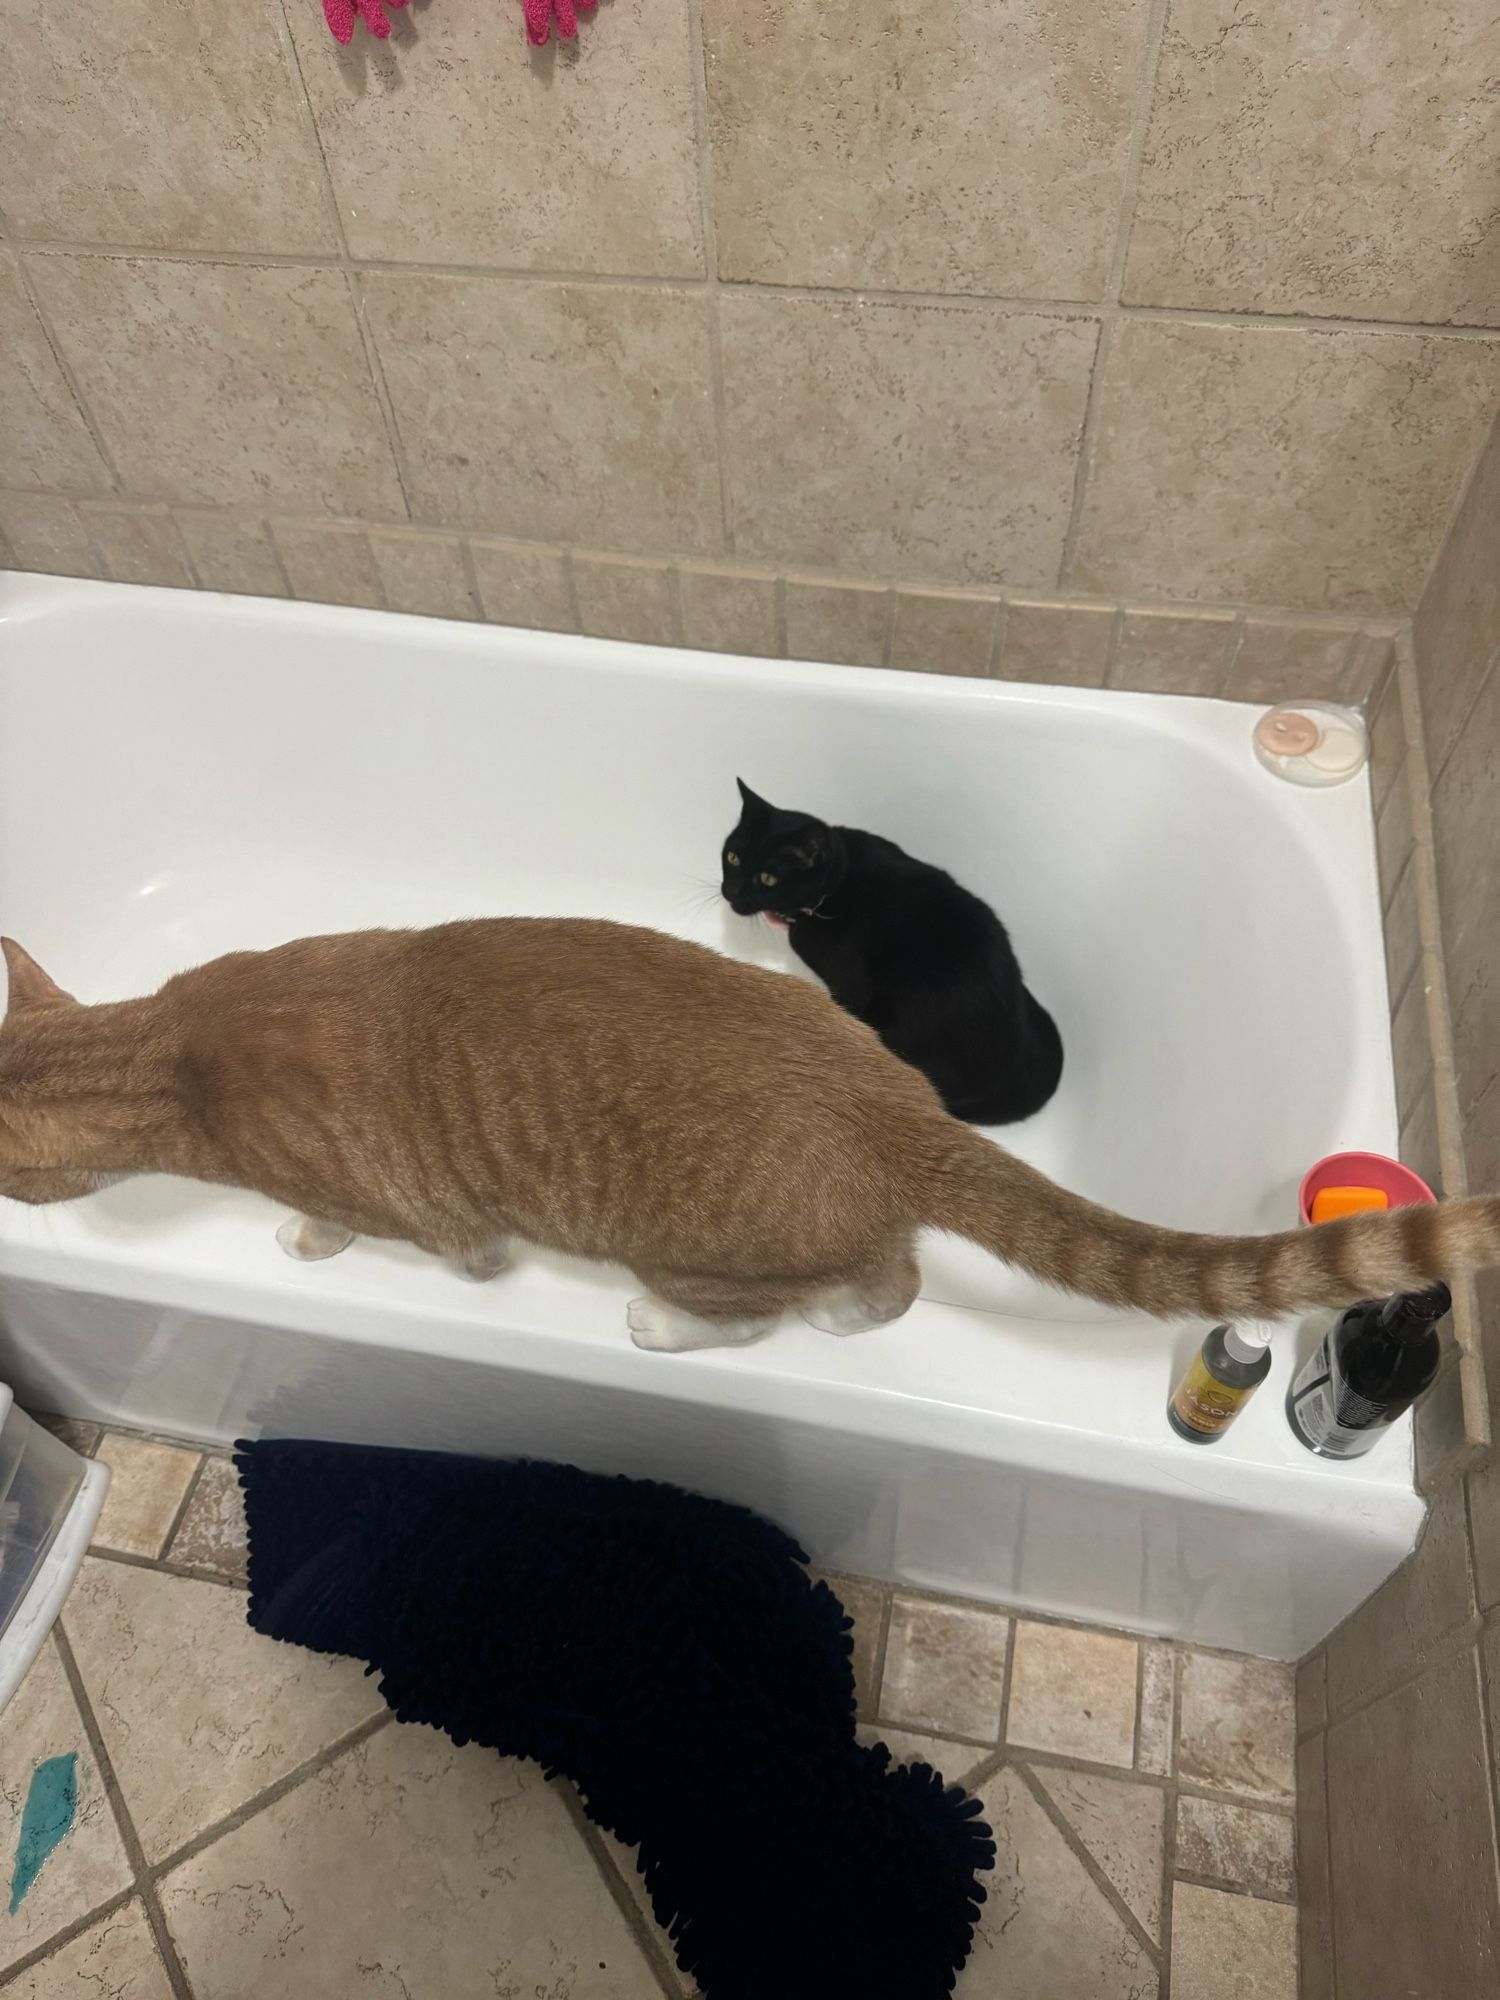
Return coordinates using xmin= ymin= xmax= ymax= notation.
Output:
xmin=922 ymin=1126 xmax=1500 ymax=1320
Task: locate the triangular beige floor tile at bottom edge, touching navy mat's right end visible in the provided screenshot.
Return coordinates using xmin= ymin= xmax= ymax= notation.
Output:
xmin=956 ymin=1768 xmax=1176 ymax=2000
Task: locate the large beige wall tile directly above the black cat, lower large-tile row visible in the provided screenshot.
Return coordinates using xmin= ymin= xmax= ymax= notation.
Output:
xmin=720 ymin=292 xmax=1098 ymax=588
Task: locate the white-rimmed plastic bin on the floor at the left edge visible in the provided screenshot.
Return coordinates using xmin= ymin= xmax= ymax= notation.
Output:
xmin=0 ymin=1382 xmax=110 ymax=1714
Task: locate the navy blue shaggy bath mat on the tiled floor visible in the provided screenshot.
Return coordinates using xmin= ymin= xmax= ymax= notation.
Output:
xmin=236 ymin=1440 xmax=994 ymax=2000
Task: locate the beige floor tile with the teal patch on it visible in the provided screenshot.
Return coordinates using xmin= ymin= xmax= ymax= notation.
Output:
xmin=0 ymin=1640 xmax=130 ymax=1968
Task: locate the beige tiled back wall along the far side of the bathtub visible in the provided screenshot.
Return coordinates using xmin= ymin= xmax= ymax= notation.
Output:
xmin=0 ymin=0 xmax=1500 ymax=700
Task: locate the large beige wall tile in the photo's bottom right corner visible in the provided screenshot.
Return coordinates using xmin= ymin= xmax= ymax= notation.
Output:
xmin=1328 ymin=1646 xmax=1500 ymax=2000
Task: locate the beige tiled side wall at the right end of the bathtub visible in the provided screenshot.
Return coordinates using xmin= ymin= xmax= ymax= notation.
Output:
xmin=1298 ymin=402 xmax=1500 ymax=2000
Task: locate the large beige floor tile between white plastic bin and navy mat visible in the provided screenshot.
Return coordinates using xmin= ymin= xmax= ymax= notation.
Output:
xmin=64 ymin=1558 xmax=382 ymax=1860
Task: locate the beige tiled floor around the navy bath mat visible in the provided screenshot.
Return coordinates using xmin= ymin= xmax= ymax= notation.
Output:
xmin=0 ymin=1428 xmax=1296 ymax=2000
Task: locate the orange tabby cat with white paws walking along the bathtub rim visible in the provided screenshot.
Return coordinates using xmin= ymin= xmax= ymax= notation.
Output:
xmin=0 ymin=918 xmax=1500 ymax=1348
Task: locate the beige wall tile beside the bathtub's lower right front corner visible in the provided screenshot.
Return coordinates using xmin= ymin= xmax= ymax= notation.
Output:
xmin=1328 ymin=1488 xmax=1474 ymax=1716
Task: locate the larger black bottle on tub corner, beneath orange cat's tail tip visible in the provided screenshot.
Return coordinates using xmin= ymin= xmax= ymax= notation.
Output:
xmin=1286 ymin=1284 xmax=1452 ymax=1458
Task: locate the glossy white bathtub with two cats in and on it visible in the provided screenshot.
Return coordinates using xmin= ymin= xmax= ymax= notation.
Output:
xmin=0 ymin=576 xmax=1422 ymax=1658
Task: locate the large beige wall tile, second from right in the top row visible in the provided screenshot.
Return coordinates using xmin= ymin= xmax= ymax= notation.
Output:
xmin=704 ymin=0 xmax=1146 ymax=298
